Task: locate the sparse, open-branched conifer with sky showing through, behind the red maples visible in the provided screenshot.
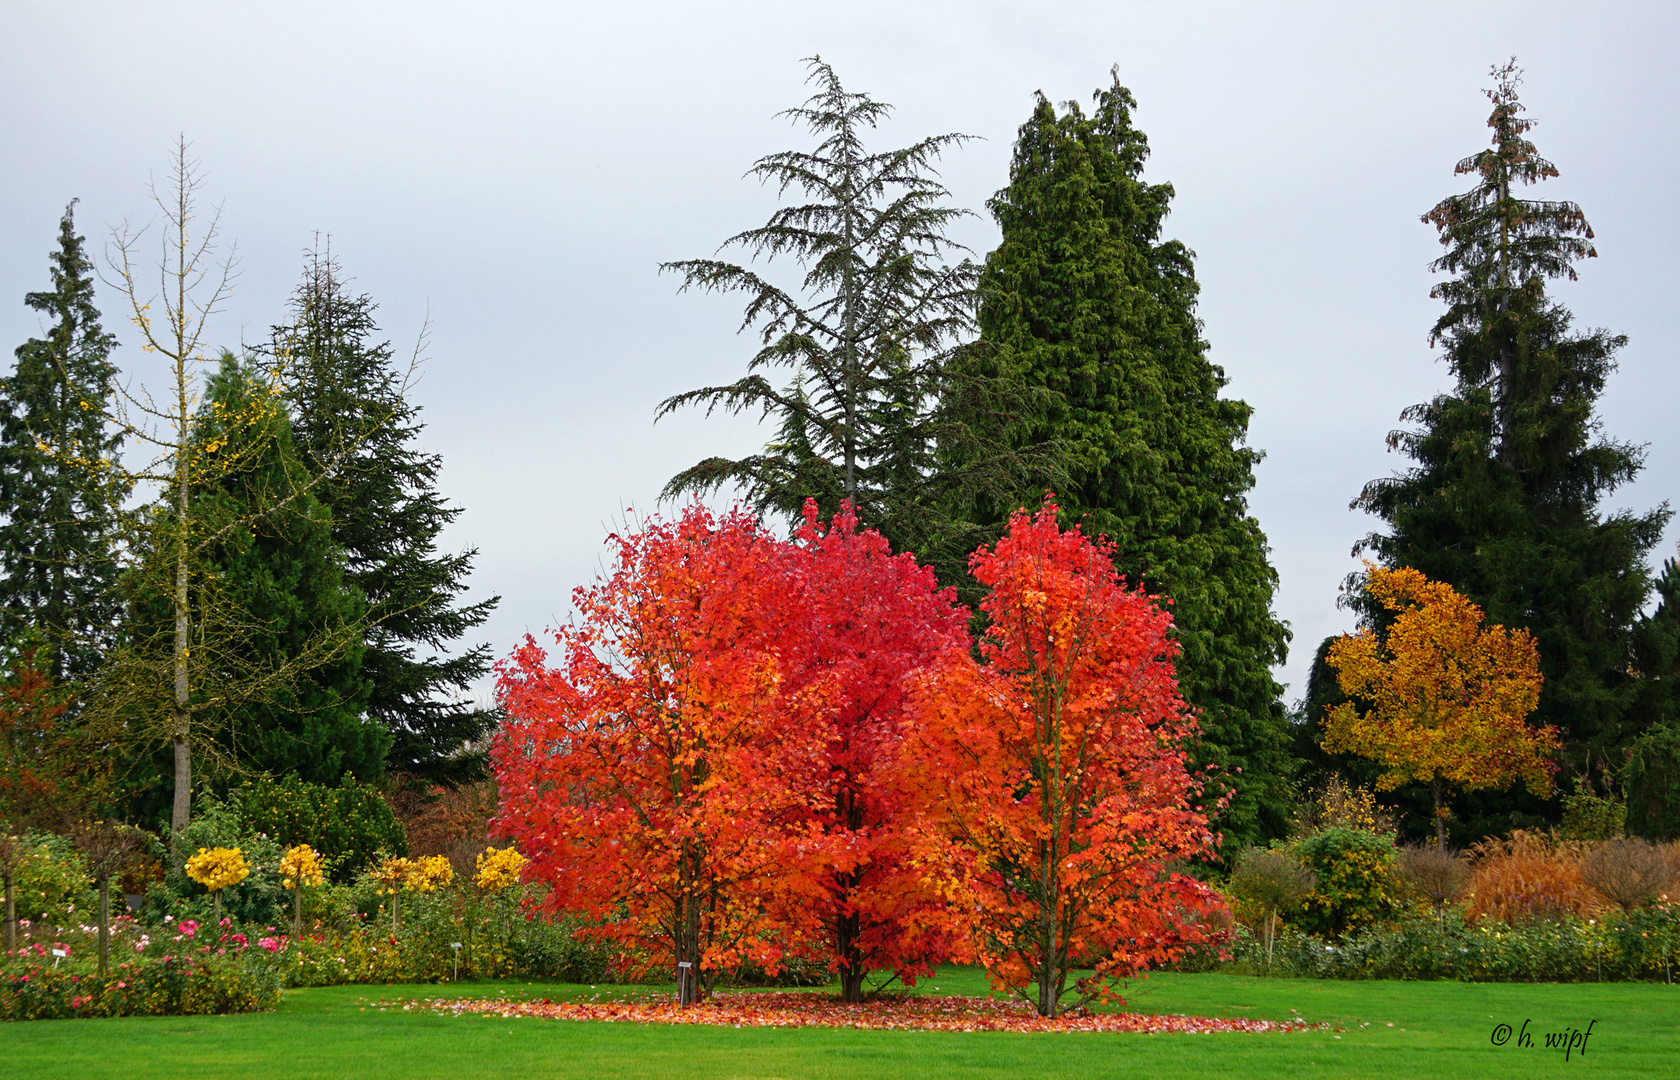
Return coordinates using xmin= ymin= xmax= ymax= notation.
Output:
xmin=657 ymin=59 xmax=1040 ymax=554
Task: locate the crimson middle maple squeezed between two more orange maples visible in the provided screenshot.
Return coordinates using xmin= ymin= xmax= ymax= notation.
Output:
xmin=781 ymin=501 xmax=969 ymax=1001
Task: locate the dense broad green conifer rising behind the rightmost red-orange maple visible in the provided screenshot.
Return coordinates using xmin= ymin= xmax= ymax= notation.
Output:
xmin=960 ymin=72 xmax=1290 ymax=850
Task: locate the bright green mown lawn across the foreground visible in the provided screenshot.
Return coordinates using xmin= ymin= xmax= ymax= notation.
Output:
xmin=0 ymin=969 xmax=1680 ymax=1080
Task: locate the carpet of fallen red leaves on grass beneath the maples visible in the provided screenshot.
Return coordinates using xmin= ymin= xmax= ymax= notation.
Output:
xmin=403 ymin=993 xmax=1327 ymax=1035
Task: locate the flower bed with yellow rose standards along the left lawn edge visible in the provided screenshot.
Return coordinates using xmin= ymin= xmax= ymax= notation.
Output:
xmin=0 ymin=781 xmax=612 ymax=1020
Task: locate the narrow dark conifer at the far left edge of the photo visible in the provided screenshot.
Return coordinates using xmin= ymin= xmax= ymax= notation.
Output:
xmin=0 ymin=202 xmax=131 ymax=679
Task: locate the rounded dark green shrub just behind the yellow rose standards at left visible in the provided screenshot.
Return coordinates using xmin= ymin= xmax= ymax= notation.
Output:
xmin=228 ymin=774 xmax=408 ymax=882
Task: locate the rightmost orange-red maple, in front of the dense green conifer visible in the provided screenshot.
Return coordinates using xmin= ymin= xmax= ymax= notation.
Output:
xmin=902 ymin=504 xmax=1220 ymax=1016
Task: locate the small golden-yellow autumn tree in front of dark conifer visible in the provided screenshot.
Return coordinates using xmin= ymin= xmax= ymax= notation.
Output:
xmin=1324 ymin=563 xmax=1559 ymax=852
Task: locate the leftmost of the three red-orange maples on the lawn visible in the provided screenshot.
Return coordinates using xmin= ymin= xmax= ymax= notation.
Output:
xmin=491 ymin=506 xmax=832 ymax=1004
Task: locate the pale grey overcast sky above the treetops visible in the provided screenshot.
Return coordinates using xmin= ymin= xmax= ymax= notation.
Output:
xmin=0 ymin=0 xmax=1680 ymax=697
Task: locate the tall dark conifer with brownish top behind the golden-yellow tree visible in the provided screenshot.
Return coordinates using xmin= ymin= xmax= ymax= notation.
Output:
xmin=1352 ymin=60 xmax=1670 ymax=838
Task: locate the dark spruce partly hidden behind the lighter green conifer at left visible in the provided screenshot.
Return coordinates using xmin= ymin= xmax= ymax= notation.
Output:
xmin=274 ymin=252 xmax=501 ymax=784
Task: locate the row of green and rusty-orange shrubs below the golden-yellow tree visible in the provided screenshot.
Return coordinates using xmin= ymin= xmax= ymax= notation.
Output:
xmin=1209 ymin=783 xmax=1680 ymax=983
